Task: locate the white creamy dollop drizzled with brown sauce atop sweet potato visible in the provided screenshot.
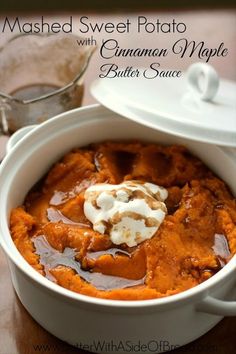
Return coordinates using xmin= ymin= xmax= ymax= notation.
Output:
xmin=84 ymin=181 xmax=168 ymax=247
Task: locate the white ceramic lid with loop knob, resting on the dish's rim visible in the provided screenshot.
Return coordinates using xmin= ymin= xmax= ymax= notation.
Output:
xmin=91 ymin=63 xmax=236 ymax=147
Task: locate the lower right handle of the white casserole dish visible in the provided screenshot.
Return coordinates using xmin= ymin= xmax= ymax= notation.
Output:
xmin=196 ymin=296 xmax=236 ymax=316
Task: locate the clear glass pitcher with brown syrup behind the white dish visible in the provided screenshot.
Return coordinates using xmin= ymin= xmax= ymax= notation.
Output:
xmin=0 ymin=34 xmax=95 ymax=134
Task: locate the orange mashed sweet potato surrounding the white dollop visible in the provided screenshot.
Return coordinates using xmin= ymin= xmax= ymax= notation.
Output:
xmin=10 ymin=142 xmax=236 ymax=300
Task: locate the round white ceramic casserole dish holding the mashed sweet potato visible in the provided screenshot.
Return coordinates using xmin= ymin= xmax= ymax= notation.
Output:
xmin=0 ymin=105 xmax=236 ymax=354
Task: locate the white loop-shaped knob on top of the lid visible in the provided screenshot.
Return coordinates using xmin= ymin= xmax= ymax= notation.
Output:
xmin=187 ymin=63 xmax=220 ymax=101
